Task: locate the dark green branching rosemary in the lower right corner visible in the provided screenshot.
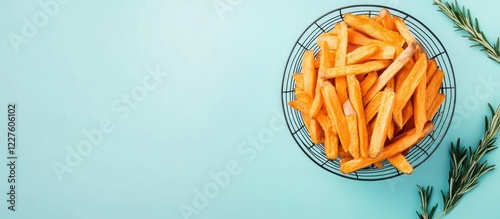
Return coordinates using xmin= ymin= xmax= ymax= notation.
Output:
xmin=417 ymin=105 xmax=500 ymax=219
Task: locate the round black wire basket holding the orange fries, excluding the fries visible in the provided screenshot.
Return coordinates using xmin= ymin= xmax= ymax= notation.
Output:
xmin=281 ymin=5 xmax=456 ymax=181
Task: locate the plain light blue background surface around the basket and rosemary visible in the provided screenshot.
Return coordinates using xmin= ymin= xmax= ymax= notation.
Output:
xmin=0 ymin=0 xmax=500 ymax=219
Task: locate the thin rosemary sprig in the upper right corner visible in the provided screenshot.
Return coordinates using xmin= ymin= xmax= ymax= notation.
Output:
xmin=434 ymin=0 xmax=500 ymax=63
